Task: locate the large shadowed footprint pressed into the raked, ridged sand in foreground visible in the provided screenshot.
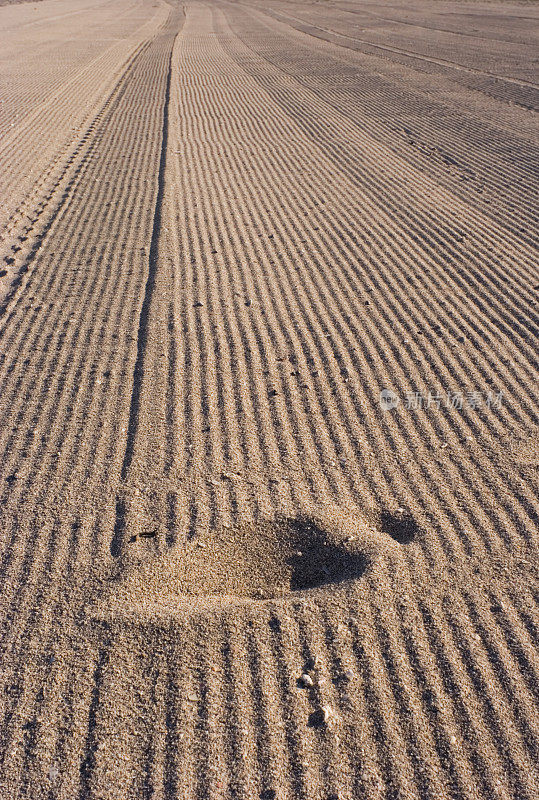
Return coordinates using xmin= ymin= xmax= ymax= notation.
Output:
xmin=99 ymin=509 xmax=418 ymax=614
